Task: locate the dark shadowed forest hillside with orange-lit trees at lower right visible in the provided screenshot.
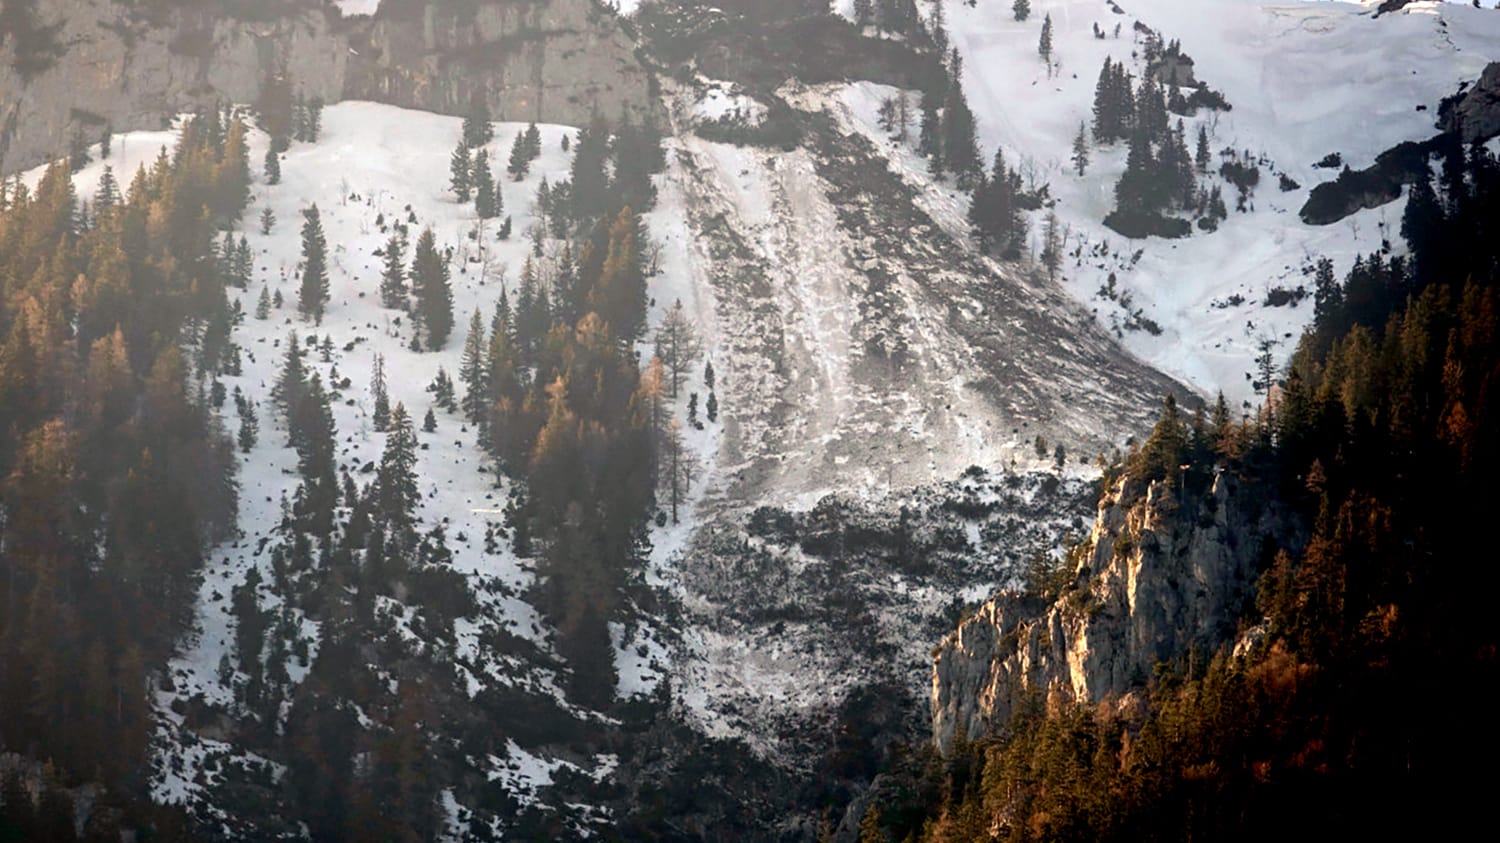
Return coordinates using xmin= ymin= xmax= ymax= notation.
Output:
xmin=860 ymin=124 xmax=1500 ymax=842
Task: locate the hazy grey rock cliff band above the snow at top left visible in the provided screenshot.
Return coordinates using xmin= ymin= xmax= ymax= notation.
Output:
xmin=0 ymin=0 xmax=653 ymax=173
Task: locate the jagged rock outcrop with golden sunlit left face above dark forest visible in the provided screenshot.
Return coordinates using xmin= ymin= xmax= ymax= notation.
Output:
xmin=932 ymin=473 xmax=1296 ymax=750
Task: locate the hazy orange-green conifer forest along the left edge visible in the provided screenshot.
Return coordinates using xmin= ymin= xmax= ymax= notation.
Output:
xmin=0 ymin=113 xmax=249 ymax=834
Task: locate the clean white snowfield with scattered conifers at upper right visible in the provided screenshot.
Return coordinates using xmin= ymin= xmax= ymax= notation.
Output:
xmin=840 ymin=0 xmax=1500 ymax=404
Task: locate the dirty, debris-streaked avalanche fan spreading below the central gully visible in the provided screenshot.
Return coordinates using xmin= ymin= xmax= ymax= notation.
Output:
xmin=639 ymin=70 xmax=1200 ymax=749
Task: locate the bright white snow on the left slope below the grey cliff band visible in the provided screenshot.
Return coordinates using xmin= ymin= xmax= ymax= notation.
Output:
xmin=26 ymin=102 xmax=648 ymax=828
